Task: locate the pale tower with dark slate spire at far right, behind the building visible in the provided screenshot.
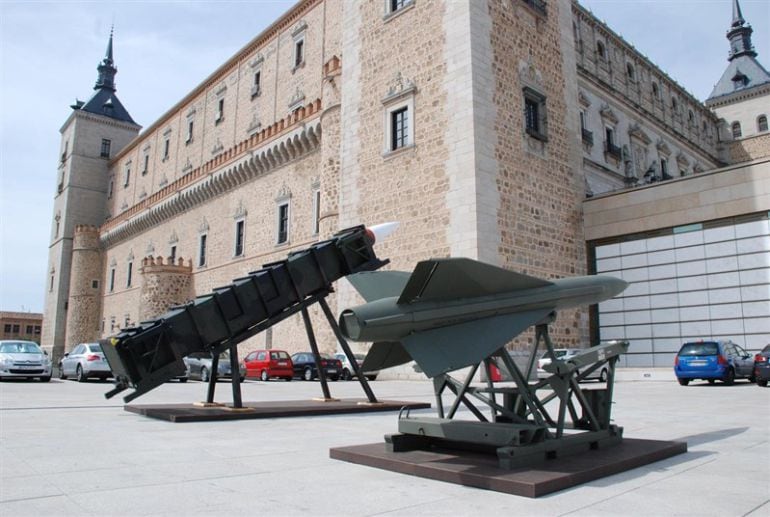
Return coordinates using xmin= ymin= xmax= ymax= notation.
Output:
xmin=706 ymin=0 xmax=770 ymax=140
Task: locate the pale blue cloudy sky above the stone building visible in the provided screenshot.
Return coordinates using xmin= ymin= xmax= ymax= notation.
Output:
xmin=0 ymin=0 xmax=770 ymax=312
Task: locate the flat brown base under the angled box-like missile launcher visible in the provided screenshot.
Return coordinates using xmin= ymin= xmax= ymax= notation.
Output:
xmin=124 ymin=399 xmax=430 ymax=422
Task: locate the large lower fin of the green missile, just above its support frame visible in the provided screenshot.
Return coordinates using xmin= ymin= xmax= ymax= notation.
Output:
xmin=403 ymin=309 xmax=552 ymax=377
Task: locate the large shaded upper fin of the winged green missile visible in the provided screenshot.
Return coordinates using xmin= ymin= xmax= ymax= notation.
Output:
xmin=398 ymin=258 xmax=552 ymax=304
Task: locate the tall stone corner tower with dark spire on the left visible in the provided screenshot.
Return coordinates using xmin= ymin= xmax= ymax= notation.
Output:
xmin=41 ymin=30 xmax=141 ymax=361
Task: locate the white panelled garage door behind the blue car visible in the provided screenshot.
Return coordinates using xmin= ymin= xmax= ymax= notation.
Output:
xmin=593 ymin=213 xmax=770 ymax=367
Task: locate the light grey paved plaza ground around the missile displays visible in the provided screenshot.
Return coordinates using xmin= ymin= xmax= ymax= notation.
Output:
xmin=0 ymin=371 xmax=770 ymax=517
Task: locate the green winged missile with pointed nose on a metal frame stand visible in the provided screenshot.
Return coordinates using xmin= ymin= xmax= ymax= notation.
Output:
xmin=339 ymin=258 xmax=628 ymax=377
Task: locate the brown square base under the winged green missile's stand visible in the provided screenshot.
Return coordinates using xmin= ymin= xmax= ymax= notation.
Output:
xmin=329 ymin=438 xmax=687 ymax=497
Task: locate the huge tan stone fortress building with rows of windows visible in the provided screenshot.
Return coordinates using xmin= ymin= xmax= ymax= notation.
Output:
xmin=43 ymin=0 xmax=765 ymax=370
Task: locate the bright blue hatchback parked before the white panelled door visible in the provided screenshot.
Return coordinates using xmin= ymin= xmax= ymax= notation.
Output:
xmin=674 ymin=340 xmax=754 ymax=386
